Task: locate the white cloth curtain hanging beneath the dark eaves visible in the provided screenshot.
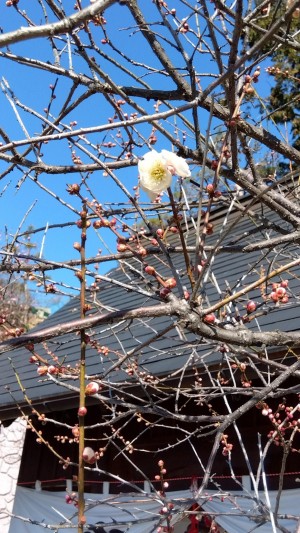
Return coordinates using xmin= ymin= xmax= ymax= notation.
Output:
xmin=9 ymin=487 xmax=300 ymax=533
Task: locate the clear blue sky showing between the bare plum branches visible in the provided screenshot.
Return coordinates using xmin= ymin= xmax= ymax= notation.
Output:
xmin=0 ymin=0 xmax=288 ymax=310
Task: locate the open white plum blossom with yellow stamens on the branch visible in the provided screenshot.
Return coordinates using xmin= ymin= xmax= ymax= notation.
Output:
xmin=138 ymin=150 xmax=191 ymax=200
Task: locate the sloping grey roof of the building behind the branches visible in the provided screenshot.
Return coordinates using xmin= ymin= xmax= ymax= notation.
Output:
xmin=0 ymin=197 xmax=300 ymax=418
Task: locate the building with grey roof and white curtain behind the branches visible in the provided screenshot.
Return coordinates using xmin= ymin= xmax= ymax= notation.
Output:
xmin=0 ymin=195 xmax=300 ymax=533
